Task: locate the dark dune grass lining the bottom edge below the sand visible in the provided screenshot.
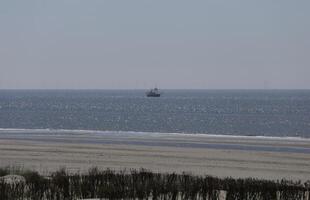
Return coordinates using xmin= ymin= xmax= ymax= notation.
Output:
xmin=0 ymin=168 xmax=310 ymax=200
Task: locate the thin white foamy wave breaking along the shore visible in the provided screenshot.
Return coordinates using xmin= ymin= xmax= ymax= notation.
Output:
xmin=0 ymin=128 xmax=310 ymax=142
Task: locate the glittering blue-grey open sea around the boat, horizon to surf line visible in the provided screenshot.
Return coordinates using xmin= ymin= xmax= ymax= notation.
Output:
xmin=0 ymin=90 xmax=310 ymax=138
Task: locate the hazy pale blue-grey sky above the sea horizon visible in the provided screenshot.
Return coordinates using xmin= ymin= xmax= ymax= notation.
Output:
xmin=0 ymin=0 xmax=310 ymax=89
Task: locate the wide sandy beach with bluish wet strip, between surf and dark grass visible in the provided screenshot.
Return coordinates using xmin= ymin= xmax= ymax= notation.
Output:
xmin=0 ymin=130 xmax=310 ymax=181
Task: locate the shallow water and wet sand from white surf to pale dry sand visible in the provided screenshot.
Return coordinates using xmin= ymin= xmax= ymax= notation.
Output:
xmin=0 ymin=129 xmax=310 ymax=154
